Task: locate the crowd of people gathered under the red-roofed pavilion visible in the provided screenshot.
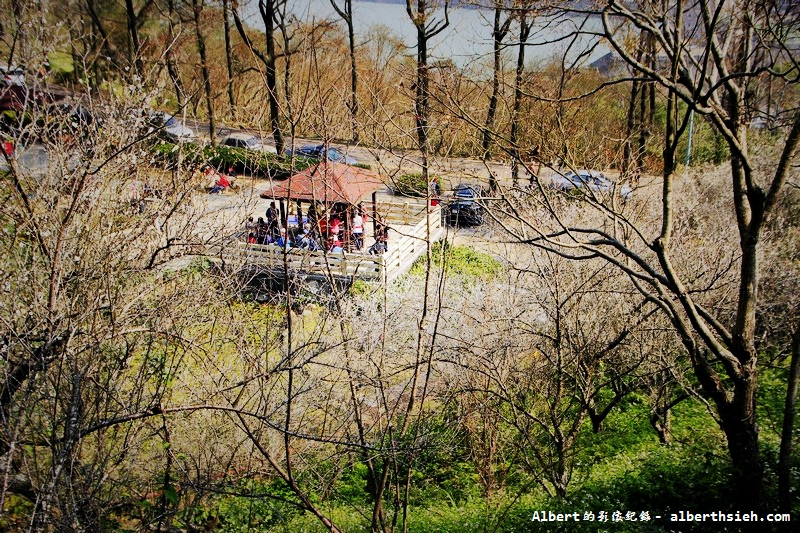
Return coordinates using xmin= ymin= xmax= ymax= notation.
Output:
xmin=246 ymin=202 xmax=389 ymax=254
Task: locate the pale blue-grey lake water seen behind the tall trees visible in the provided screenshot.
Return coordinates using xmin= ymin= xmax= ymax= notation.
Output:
xmin=241 ymin=0 xmax=608 ymax=67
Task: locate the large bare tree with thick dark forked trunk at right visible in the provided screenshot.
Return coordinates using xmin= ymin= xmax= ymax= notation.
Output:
xmin=444 ymin=2 xmax=800 ymax=511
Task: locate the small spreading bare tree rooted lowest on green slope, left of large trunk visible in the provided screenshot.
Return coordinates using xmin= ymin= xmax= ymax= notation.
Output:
xmin=465 ymin=252 xmax=653 ymax=498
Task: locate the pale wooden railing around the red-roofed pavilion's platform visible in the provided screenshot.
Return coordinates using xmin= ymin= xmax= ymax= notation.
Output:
xmin=221 ymin=202 xmax=444 ymax=282
